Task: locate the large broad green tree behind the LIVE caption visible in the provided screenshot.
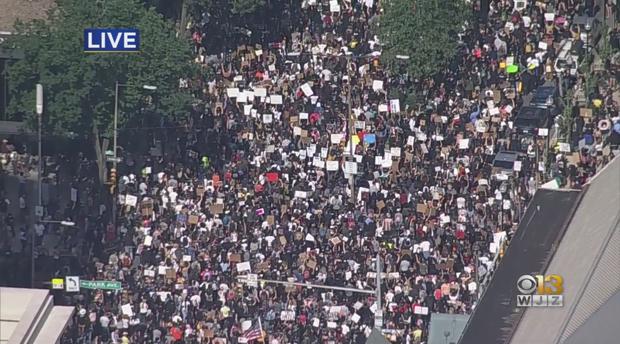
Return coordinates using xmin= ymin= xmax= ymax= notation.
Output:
xmin=8 ymin=0 xmax=195 ymax=180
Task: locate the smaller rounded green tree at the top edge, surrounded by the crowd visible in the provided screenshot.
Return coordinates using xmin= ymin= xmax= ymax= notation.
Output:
xmin=378 ymin=0 xmax=471 ymax=78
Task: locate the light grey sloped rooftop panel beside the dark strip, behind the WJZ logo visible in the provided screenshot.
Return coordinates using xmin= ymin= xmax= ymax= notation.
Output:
xmin=510 ymin=157 xmax=620 ymax=344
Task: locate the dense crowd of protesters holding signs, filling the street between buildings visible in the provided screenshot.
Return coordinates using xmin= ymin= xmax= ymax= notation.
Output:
xmin=2 ymin=0 xmax=620 ymax=344
